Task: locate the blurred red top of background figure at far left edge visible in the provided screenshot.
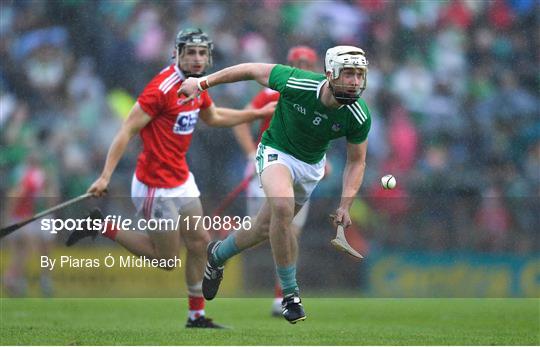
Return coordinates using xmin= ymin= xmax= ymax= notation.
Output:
xmin=13 ymin=165 xmax=45 ymax=219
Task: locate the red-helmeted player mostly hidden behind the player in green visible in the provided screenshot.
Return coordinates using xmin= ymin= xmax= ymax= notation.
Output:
xmin=233 ymin=46 xmax=328 ymax=317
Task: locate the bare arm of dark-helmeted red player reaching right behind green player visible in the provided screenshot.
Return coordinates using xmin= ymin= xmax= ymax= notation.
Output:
xmin=199 ymin=101 xmax=277 ymax=127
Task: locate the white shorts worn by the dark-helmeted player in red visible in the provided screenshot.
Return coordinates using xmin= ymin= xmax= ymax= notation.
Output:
xmin=131 ymin=172 xmax=201 ymax=219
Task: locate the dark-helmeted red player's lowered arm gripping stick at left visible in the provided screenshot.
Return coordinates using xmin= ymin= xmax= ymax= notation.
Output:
xmin=88 ymin=103 xmax=152 ymax=196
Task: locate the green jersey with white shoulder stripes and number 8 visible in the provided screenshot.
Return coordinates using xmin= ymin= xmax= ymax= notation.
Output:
xmin=261 ymin=65 xmax=371 ymax=164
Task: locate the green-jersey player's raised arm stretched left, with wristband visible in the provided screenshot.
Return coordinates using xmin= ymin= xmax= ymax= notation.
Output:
xmin=178 ymin=63 xmax=276 ymax=103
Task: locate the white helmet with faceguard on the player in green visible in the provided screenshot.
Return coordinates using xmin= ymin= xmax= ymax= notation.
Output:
xmin=324 ymin=46 xmax=368 ymax=105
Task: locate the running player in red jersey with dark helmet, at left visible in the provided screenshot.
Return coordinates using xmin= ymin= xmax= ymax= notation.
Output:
xmin=67 ymin=29 xmax=275 ymax=328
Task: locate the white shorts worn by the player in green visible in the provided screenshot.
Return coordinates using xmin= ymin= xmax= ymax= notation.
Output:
xmin=256 ymin=144 xmax=326 ymax=205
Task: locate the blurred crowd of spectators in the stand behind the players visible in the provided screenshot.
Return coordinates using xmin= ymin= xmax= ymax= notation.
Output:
xmin=0 ymin=0 xmax=540 ymax=253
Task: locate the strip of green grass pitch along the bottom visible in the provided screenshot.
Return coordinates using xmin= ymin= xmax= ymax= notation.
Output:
xmin=0 ymin=298 xmax=540 ymax=345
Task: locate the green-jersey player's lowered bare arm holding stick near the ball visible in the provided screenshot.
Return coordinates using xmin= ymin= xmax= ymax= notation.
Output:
xmin=334 ymin=140 xmax=368 ymax=227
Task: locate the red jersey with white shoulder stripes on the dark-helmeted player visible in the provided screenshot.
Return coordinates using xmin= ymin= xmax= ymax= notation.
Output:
xmin=135 ymin=64 xmax=212 ymax=188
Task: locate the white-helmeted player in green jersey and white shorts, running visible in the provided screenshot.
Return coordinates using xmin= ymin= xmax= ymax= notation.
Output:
xmin=178 ymin=46 xmax=371 ymax=323
